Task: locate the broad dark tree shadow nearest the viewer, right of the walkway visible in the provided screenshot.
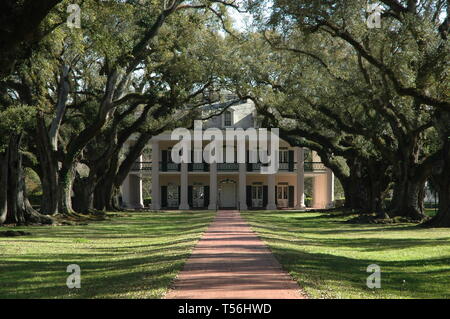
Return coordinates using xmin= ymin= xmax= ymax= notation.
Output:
xmin=273 ymin=247 xmax=450 ymax=298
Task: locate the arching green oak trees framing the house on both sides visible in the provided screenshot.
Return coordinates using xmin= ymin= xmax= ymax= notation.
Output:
xmin=0 ymin=0 xmax=450 ymax=226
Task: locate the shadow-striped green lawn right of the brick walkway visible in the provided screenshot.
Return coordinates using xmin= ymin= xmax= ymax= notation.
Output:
xmin=242 ymin=211 xmax=450 ymax=298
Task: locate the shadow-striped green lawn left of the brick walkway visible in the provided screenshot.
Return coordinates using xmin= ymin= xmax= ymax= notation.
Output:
xmin=0 ymin=211 xmax=214 ymax=298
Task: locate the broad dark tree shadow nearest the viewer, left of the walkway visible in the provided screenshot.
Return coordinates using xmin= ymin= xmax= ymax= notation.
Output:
xmin=0 ymin=244 xmax=196 ymax=298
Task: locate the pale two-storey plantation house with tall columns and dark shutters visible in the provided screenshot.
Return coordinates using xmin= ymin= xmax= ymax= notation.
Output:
xmin=121 ymin=100 xmax=334 ymax=210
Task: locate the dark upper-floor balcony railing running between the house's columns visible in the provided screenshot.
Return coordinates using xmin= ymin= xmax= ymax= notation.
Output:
xmin=131 ymin=162 xmax=326 ymax=172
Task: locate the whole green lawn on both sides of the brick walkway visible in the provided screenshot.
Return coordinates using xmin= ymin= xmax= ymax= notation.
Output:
xmin=0 ymin=211 xmax=450 ymax=298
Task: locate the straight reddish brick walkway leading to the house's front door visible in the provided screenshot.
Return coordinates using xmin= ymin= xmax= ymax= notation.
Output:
xmin=166 ymin=211 xmax=305 ymax=299
